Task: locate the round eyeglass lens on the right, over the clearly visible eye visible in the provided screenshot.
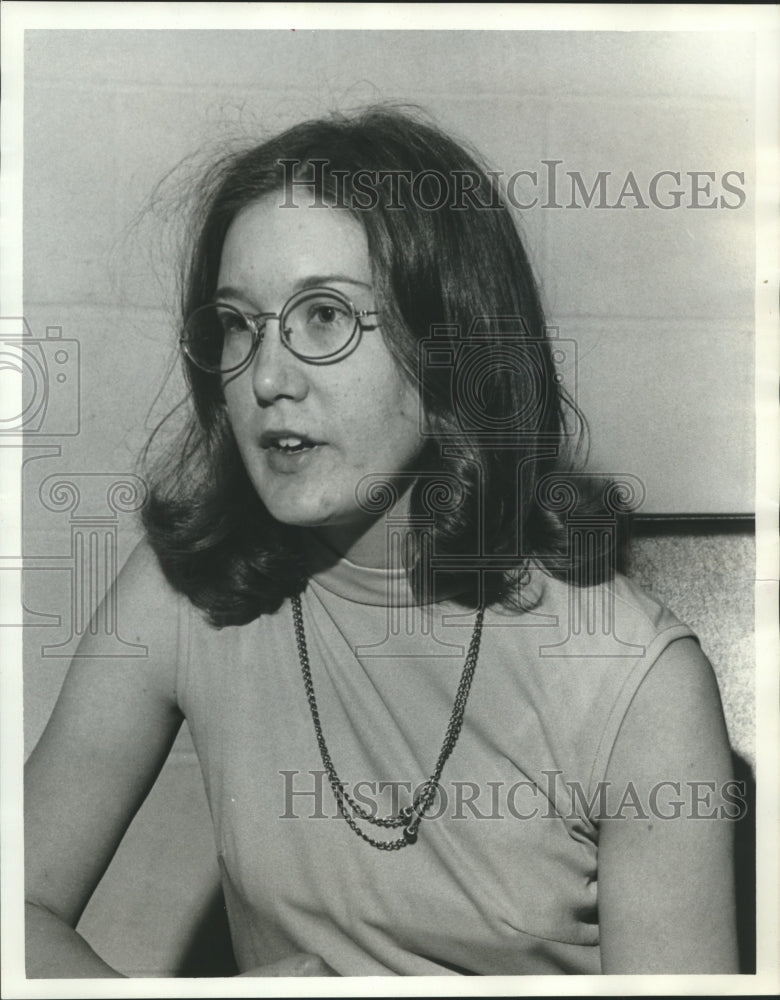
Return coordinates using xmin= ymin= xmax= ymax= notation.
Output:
xmin=282 ymin=289 xmax=358 ymax=360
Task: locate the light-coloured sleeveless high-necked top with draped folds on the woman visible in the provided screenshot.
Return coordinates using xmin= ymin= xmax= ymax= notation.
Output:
xmin=178 ymin=548 xmax=692 ymax=976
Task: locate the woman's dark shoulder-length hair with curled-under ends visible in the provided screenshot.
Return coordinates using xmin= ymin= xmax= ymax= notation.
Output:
xmin=143 ymin=108 xmax=604 ymax=627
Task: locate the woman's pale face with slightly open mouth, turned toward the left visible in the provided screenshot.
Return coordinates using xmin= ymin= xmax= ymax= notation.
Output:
xmin=217 ymin=194 xmax=423 ymax=551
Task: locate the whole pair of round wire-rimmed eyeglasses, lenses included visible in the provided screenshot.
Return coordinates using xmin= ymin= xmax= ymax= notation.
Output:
xmin=179 ymin=288 xmax=378 ymax=375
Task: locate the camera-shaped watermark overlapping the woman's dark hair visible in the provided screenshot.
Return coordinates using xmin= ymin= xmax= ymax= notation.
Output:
xmin=418 ymin=315 xmax=577 ymax=447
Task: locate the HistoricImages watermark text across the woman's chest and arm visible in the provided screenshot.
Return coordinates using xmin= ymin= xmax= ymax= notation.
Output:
xmin=278 ymin=769 xmax=748 ymax=822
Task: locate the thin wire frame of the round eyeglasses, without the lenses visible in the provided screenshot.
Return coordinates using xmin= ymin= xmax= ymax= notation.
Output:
xmin=179 ymin=285 xmax=379 ymax=375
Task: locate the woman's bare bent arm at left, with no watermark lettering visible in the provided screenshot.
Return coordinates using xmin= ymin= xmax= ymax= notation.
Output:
xmin=25 ymin=543 xmax=182 ymax=978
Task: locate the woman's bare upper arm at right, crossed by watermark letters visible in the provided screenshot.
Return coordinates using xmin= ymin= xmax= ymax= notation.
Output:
xmin=599 ymin=639 xmax=737 ymax=974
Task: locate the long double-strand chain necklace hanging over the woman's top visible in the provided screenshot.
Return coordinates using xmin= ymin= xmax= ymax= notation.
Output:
xmin=292 ymin=594 xmax=485 ymax=851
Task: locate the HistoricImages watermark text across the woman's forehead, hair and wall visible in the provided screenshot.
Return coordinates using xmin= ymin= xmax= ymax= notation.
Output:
xmin=279 ymin=159 xmax=747 ymax=212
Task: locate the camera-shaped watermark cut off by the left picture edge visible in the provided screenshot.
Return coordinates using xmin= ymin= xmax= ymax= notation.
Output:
xmin=0 ymin=317 xmax=81 ymax=437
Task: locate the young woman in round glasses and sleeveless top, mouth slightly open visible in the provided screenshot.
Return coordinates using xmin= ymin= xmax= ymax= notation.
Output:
xmin=26 ymin=110 xmax=736 ymax=976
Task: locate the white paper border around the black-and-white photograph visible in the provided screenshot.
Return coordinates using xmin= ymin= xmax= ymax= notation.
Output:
xmin=0 ymin=0 xmax=780 ymax=998
